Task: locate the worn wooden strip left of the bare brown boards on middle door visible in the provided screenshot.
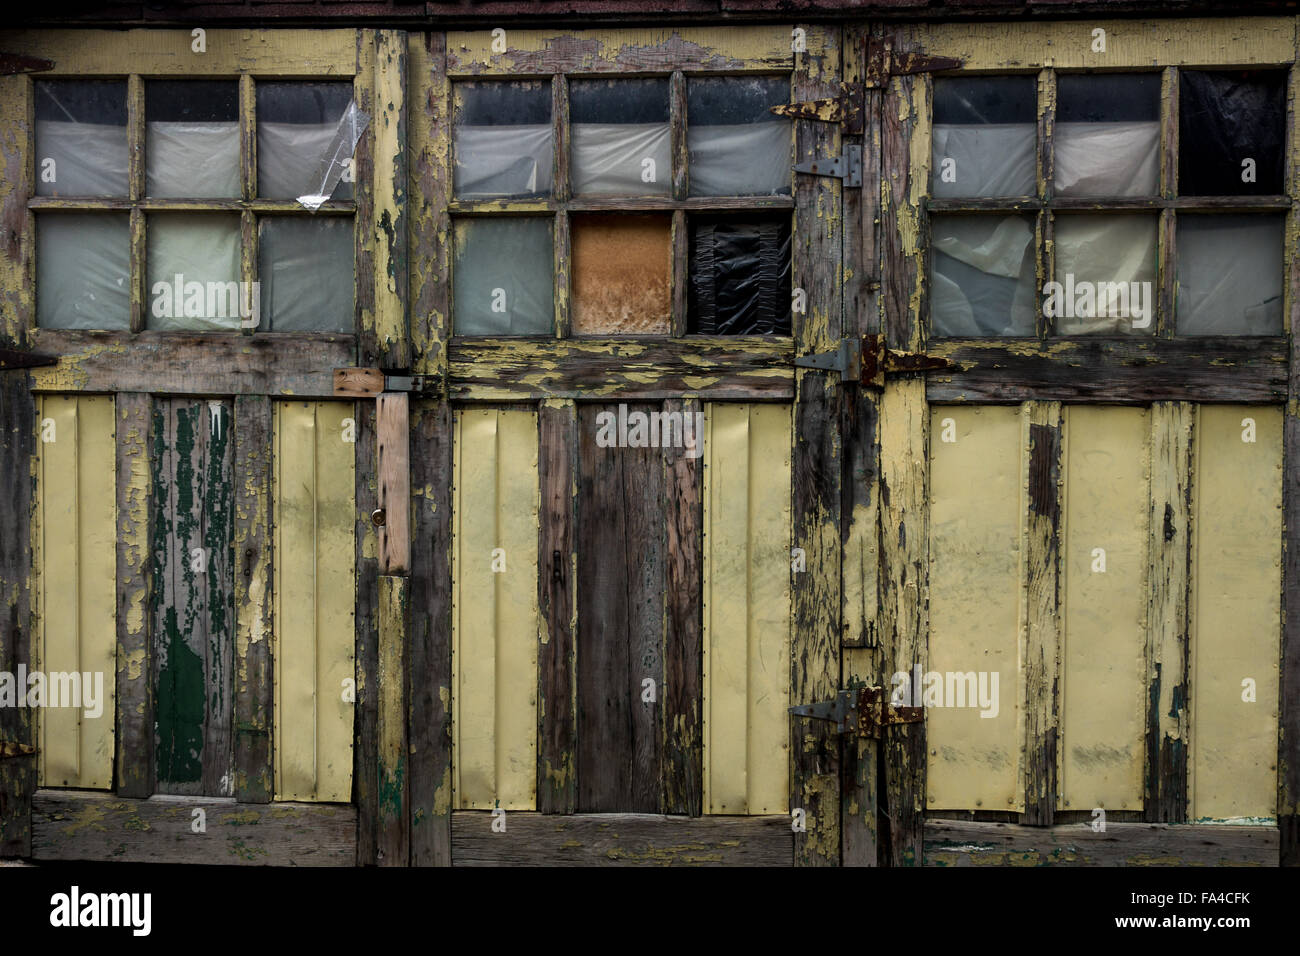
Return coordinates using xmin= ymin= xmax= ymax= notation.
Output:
xmin=537 ymin=402 xmax=577 ymax=813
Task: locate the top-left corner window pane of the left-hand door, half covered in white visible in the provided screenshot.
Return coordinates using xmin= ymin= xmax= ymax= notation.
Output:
xmin=35 ymin=79 xmax=127 ymax=196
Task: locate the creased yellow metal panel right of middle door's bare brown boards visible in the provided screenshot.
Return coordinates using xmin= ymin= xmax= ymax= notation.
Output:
xmin=703 ymin=403 xmax=792 ymax=813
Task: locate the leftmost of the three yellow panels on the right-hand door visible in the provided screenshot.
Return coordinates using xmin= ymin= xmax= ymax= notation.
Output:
xmin=925 ymin=406 xmax=1026 ymax=812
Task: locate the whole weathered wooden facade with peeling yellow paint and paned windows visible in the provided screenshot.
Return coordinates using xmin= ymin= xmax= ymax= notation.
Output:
xmin=0 ymin=0 xmax=1300 ymax=866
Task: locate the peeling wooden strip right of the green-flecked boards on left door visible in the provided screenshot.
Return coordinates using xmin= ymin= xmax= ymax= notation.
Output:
xmin=233 ymin=395 xmax=273 ymax=804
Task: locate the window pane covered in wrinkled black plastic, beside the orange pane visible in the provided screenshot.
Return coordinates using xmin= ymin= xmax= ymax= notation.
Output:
xmin=689 ymin=215 xmax=790 ymax=336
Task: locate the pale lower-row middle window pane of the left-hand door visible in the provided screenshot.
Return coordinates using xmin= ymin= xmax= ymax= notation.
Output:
xmin=146 ymin=212 xmax=244 ymax=332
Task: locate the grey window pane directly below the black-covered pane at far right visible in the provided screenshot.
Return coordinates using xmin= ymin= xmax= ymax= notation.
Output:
xmin=1177 ymin=215 xmax=1284 ymax=336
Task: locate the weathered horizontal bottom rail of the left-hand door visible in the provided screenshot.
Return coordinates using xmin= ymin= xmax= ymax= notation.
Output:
xmin=31 ymin=790 xmax=356 ymax=866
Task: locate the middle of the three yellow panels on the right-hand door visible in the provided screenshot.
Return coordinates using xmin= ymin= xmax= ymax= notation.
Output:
xmin=1057 ymin=406 xmax=1151 ymax=810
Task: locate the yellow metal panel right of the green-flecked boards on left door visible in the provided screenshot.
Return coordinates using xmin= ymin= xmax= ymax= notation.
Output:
xmin=272 ymin=402 xmax=355 ymax=803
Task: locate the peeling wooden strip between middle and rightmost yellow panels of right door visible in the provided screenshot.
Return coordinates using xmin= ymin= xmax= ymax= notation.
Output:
xmin=1144 ymin=402 xmax=1196 ymax=823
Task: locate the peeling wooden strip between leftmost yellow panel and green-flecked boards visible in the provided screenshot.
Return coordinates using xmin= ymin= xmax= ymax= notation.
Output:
xmin=116 ymin=393 xmax=152 ymax=797
